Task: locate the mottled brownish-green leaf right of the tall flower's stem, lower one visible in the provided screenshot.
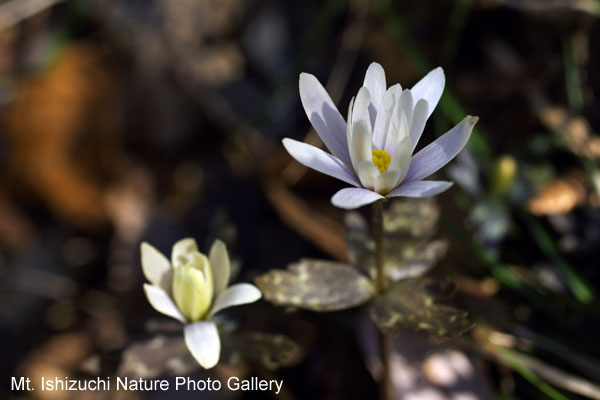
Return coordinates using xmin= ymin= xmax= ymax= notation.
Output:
xmin=371 ymin=278 xmax=473 ymax=337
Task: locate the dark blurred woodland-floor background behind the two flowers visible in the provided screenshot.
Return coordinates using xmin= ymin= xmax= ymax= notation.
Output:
xmin=0 ymin=0 xmax=600 ymax=399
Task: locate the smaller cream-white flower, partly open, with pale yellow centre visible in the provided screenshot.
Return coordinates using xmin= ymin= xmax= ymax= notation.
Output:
xmin=141 ymin=239 xmax=261 ymax=369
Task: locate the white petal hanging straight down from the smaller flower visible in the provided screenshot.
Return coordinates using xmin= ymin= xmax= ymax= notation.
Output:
xmin=183 ymin=321 xmax=221 ymax=369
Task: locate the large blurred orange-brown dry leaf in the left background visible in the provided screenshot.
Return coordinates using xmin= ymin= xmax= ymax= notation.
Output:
xmin=4 ymin=45 xmax=123 ymax=228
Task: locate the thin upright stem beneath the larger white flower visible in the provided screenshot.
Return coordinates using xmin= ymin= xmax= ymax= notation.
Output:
xmin=373 ymin=199 xmax=394 ymax=400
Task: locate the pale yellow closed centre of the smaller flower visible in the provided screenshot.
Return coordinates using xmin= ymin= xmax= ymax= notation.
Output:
xmin=173 ymin=253 xmax=213 ymax=322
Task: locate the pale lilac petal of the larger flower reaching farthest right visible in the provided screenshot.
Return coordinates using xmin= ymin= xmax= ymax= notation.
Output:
xmin=404 ymin=115 xmax=478 ymax=182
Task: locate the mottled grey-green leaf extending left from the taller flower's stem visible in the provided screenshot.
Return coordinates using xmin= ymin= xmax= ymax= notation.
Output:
xmin=255 ymin=259 xmax=375 ymax=311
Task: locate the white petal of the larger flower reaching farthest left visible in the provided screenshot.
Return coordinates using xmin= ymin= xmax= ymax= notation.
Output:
xmin=283 ymin=138 xmax=360 ymax=186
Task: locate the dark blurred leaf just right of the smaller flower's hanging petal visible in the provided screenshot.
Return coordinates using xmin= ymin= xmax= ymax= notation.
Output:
xmin=222 ymin=332 xmax=299 ymax=370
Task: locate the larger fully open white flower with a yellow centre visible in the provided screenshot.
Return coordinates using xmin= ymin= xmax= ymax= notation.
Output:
xmin=283 ymin=63 xmax=477 ymax=209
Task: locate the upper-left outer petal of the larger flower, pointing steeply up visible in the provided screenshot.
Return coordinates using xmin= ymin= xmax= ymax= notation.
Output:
xmin=299 ymin=73 xmax=350 ymax=164
